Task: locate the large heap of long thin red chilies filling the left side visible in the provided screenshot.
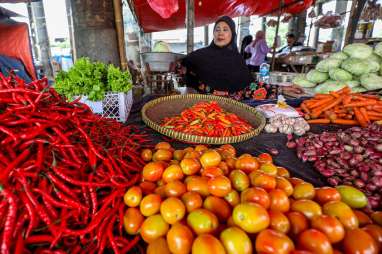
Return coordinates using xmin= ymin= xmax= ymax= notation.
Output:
xmin=0 ymin=75 xmax=146 ymax=253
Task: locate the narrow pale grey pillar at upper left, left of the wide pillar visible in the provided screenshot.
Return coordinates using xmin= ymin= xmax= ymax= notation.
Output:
xmin=31 ymin=0 xmax=53 ymax=79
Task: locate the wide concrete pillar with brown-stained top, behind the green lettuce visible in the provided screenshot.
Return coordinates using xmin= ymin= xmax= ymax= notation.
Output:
xmin=71 ymin=0 xmax=120 ymax=66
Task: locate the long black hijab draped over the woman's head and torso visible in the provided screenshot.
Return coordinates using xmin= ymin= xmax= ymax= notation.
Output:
xmin=183 ymin=16 xmax=252 ymax=93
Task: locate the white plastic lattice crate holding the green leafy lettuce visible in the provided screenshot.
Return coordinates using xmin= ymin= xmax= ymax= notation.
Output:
xmin=80 ymin=90 xmax=133 ymax=122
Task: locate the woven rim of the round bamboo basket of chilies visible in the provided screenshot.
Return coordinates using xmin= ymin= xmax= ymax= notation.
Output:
xmin=141 ymin=94 xmax=266 ymax=144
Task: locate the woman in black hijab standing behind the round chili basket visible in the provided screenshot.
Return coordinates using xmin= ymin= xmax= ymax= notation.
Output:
xmin=182 ymin=16 xmax=253 ymax=99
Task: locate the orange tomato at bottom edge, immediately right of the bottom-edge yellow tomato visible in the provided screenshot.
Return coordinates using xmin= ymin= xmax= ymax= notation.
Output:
xmin=256 ymin=229 xmax=294 ymax=254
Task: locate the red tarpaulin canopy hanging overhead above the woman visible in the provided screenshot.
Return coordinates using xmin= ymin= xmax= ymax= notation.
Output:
xmin=133 ymin=0 xmax=314 ymax=32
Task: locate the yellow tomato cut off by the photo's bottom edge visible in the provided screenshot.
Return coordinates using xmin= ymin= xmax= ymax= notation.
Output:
xmin=220 ymin=227 xmax=253 ymax=254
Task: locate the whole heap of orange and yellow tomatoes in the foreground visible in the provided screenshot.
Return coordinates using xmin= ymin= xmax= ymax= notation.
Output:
xmin=124 ymin=142 xmax=382 ymax=254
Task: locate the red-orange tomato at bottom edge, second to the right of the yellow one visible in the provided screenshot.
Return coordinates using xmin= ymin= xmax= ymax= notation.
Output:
xmin=298 ymin=229 xmax=333 ymax=254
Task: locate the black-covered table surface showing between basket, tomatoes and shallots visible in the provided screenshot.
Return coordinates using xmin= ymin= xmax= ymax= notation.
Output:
xmin=127 ymin=96 xmax=344 ymax=186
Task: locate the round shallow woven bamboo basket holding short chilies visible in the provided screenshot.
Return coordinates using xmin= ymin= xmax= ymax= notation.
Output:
xmin=142 ymin=94 xmax=266 ymax=145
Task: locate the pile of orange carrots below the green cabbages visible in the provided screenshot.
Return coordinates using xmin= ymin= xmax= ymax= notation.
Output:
xmin=301 ymin=87 xmax=382 ymax=127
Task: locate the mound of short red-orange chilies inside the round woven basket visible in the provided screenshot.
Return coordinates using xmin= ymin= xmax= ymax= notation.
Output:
xmin=162 ymin=101 xmax=253 ymax=137
